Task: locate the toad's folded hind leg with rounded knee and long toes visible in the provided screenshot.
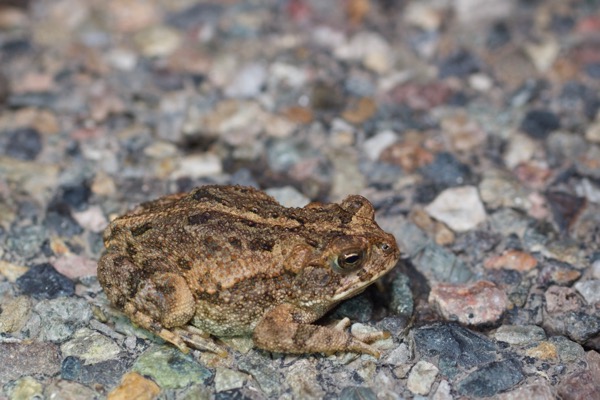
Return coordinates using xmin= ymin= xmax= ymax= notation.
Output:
xmin=123 ymin=272 xmax=223 ymax=354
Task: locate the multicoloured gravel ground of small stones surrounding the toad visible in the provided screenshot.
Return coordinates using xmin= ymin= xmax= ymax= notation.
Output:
xmin=0 ymin=0 xmax=600 ymax=400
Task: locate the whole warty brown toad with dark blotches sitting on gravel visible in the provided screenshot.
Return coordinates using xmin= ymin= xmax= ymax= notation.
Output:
xmin=98 ymin=185 xmax=399 ymax=356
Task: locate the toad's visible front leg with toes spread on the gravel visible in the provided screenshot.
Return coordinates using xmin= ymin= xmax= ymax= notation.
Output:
xmin=253 ymin=304 xmax=389 ymax=358
